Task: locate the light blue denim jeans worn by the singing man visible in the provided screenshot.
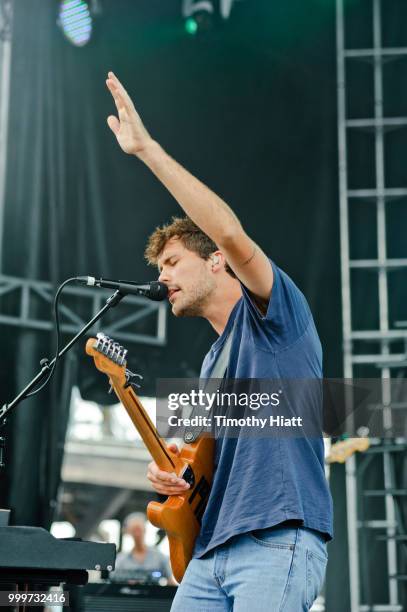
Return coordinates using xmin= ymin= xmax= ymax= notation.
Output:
xmin=171 ymin=527 xmax=328 ymax=612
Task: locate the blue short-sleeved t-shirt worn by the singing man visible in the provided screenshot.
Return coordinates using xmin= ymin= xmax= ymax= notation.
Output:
xmin=193 ymin=262 xmax=333 ymax=557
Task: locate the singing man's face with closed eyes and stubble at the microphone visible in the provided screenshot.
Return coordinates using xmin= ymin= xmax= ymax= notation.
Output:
xmin=157 ymin=238 xmax=216 ymax=317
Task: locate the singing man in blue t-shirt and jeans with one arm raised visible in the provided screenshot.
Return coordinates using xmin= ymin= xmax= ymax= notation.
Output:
xmin=106 ymin=72 xmax=332 ymax=612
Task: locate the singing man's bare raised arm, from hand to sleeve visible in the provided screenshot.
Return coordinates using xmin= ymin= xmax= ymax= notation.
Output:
xmin=106 ymin=72 xmax=273 ymax=300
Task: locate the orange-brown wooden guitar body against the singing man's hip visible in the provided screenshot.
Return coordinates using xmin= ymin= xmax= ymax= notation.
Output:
xmin=147 ymin=437 xmax=214 ymax=582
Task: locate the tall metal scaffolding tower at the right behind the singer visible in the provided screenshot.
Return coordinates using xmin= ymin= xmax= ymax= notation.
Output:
xmin=336 ymin=0 xmax=407 ymax=612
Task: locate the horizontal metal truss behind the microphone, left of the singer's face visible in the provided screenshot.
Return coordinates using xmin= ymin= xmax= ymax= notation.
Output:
xmin=0 ymin=275 xmax=167 ymax=346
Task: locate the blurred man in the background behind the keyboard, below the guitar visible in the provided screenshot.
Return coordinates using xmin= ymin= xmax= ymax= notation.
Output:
xmin=109 ymin=512 xmax=172 ymax=582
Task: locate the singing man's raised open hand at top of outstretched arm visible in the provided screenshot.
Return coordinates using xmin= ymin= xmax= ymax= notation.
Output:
xmin=106 ymin=72 xmax=152 ymax=155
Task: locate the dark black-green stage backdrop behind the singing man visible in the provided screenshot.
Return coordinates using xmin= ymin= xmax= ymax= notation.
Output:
xmin=1 ymin=0 xmax=342 ymax=604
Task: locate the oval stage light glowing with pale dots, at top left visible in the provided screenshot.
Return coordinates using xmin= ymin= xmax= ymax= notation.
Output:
xmin=58 ymin=0 xmax=92 ymax=47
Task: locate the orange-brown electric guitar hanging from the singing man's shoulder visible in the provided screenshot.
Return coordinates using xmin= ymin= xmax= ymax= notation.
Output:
xmin=86 ymin=334 xmax=214 ymax=582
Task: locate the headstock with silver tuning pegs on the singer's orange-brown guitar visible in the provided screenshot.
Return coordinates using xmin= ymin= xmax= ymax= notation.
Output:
xmin=86 ymin=333 xmax=128 ymax=383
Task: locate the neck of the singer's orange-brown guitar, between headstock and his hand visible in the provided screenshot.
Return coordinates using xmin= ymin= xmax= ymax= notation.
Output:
xmin=111 ymin=380 xmax=184 ymax=473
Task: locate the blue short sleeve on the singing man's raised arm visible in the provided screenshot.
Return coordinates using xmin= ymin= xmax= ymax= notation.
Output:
xmin=242 ymin=260 xmax=312 ymax=345
